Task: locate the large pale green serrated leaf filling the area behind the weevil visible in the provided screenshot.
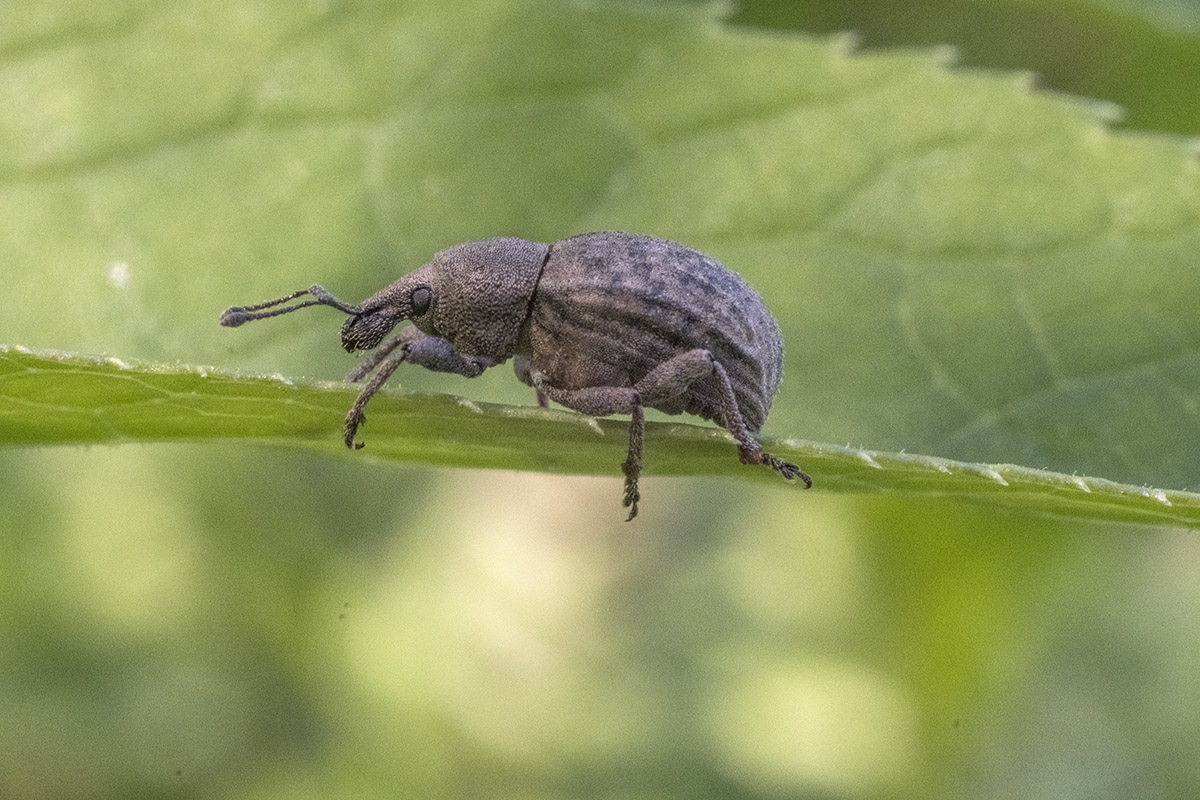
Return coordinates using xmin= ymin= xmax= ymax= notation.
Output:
xmin=0 ymin=0 xmax=1200 ymax=507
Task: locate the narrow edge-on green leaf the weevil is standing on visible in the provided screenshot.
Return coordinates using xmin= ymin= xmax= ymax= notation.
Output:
xmin=0 ymin=348 xmax=1200 ymax=525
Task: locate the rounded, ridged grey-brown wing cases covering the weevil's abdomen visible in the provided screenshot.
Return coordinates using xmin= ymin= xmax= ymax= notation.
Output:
xmin=529 ymin=231 xmax=784 ymax=432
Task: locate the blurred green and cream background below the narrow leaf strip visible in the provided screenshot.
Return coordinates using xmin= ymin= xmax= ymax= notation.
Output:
xmin=0 ymin=446 xmax=1200 ymax=798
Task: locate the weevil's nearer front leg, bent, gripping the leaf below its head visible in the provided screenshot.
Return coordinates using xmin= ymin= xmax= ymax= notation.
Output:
xmin=346 ymin=325 xmax=492 ymax=450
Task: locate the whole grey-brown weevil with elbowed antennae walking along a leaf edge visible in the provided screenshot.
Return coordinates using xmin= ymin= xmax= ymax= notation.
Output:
xmin=221 ymin=230 xmax=812 ymax=519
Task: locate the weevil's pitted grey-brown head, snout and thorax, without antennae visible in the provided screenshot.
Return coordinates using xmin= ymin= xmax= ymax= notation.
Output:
xmin=342 ymin=239 xmax=550 ymax=361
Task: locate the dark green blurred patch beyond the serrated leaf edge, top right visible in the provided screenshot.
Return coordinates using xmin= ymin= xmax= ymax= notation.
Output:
xmin=730 ymin=0 xmax=1200 ymax=136
